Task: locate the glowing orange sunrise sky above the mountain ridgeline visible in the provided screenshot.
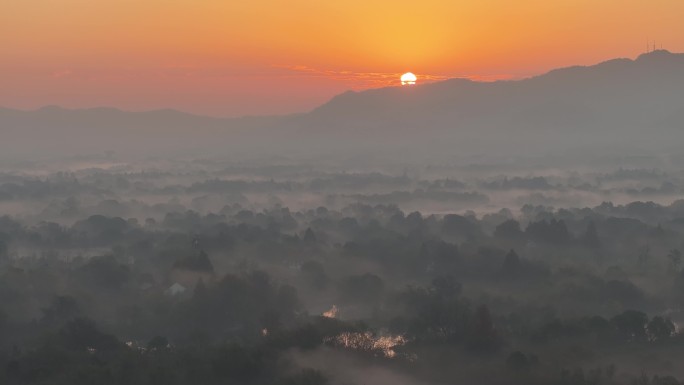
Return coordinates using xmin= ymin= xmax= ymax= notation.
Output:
xmin=0 ymin=0 xmax=684 ymax=116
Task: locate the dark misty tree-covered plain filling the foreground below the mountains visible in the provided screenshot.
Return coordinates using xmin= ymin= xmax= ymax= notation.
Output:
xmin=0 ymin=158 xmax=684 ymax=385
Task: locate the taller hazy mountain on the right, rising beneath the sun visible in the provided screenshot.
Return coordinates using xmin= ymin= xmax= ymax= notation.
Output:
xmin=292 ymin=51 xmax=684 ymax=152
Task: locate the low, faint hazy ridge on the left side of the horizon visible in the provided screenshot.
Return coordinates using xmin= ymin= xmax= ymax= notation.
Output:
xmin=0 ymin=106 xmax=281 ymax=156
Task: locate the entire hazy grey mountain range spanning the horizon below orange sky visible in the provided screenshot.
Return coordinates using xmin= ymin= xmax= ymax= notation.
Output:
xmin=0 ymin=50 xmax=684 ymax=159
